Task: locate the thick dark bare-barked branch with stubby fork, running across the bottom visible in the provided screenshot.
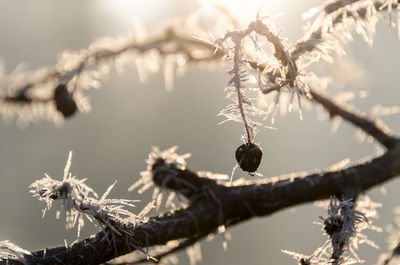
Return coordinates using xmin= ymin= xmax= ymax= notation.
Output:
xmin=0 ymin=138 xmax=400 ymax=265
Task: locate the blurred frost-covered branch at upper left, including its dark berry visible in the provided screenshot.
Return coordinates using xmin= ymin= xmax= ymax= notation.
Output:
xmin=0 ymin=27 xmax=223 ymax=121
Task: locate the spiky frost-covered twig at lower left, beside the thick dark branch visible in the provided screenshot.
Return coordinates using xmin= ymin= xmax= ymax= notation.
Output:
xmin=30 ymin=152 xmax=141 ymax=236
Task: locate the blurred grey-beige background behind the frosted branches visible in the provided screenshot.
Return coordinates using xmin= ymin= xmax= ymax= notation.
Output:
xmin=0 ymin=0 xmax=400 ymax=265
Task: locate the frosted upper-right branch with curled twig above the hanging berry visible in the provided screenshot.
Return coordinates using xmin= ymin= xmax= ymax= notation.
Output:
xmin=216 ymin=0 xmax=398 ymax=140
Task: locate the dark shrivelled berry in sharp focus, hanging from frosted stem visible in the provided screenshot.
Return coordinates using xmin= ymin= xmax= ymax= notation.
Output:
xmin=235 ymin=143 xmax=262 ymax=176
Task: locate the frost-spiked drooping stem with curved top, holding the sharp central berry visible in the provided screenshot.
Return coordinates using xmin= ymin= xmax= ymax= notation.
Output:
xmin=214 ymin=19 xmax=286 ymax=138
